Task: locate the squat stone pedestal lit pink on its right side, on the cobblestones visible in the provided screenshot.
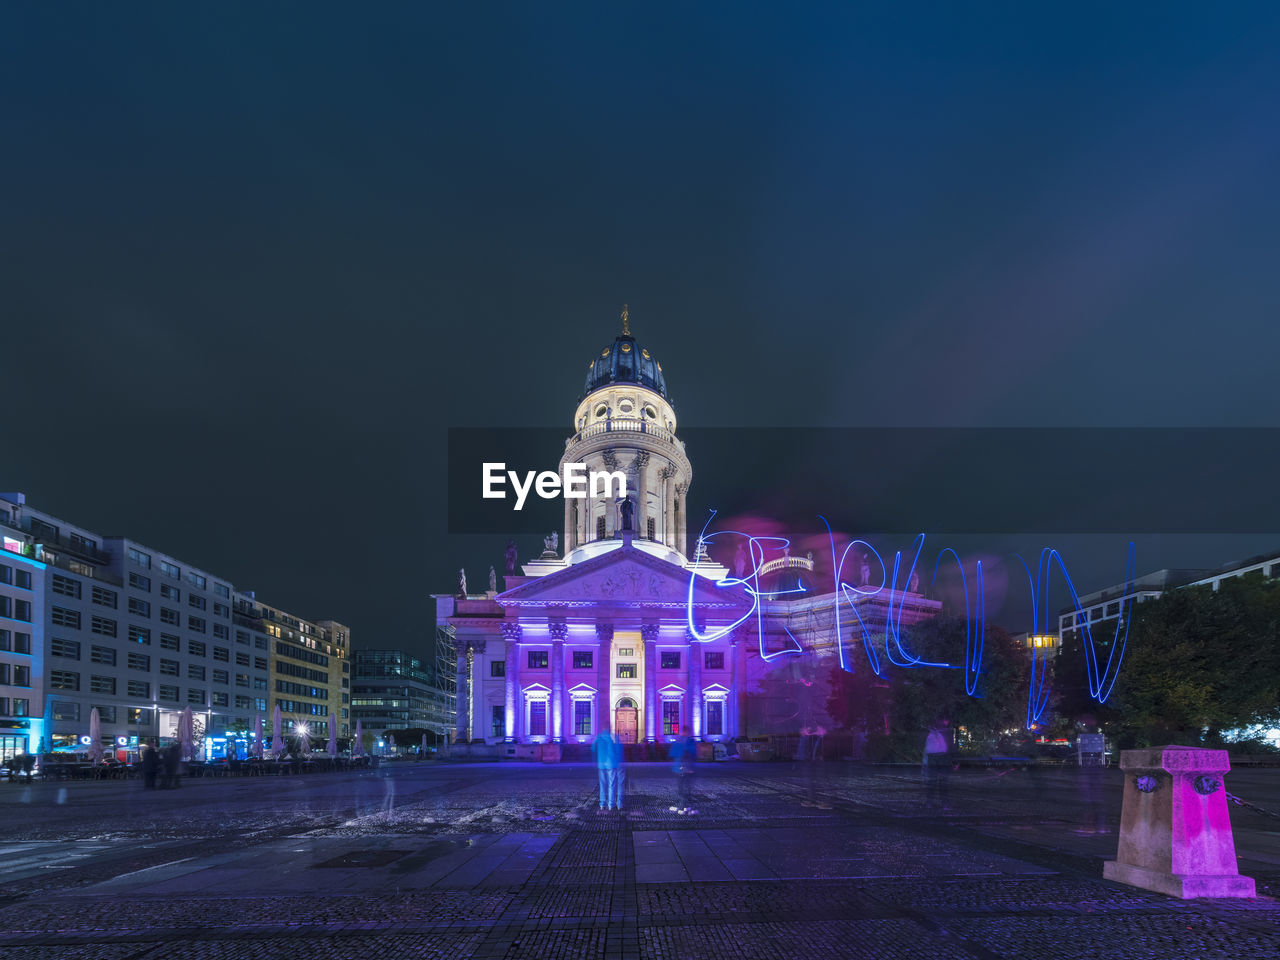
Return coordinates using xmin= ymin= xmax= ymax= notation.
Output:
xmin=1102 ymin=746 xmax=1256 ymax=900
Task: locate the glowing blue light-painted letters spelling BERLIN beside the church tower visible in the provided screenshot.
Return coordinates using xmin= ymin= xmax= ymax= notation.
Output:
xmin=686 ymin=511 xmax=1135 ymax=728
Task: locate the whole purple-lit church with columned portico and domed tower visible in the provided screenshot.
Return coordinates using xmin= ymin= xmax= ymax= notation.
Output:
xmin=435 ymin=312 xmax=940 ymax=753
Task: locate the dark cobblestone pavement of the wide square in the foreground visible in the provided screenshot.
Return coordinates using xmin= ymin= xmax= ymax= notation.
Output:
xmin=0 ymin=763 xmax=1280 ymax=960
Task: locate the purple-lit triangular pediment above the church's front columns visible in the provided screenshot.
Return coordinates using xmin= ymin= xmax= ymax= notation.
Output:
xmin=494 ymin=545 xmax=750 ymax=616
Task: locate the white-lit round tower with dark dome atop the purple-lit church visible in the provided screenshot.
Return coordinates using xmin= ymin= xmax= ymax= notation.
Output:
xmin=561 ymin=307 xmax=694 ymax=564
